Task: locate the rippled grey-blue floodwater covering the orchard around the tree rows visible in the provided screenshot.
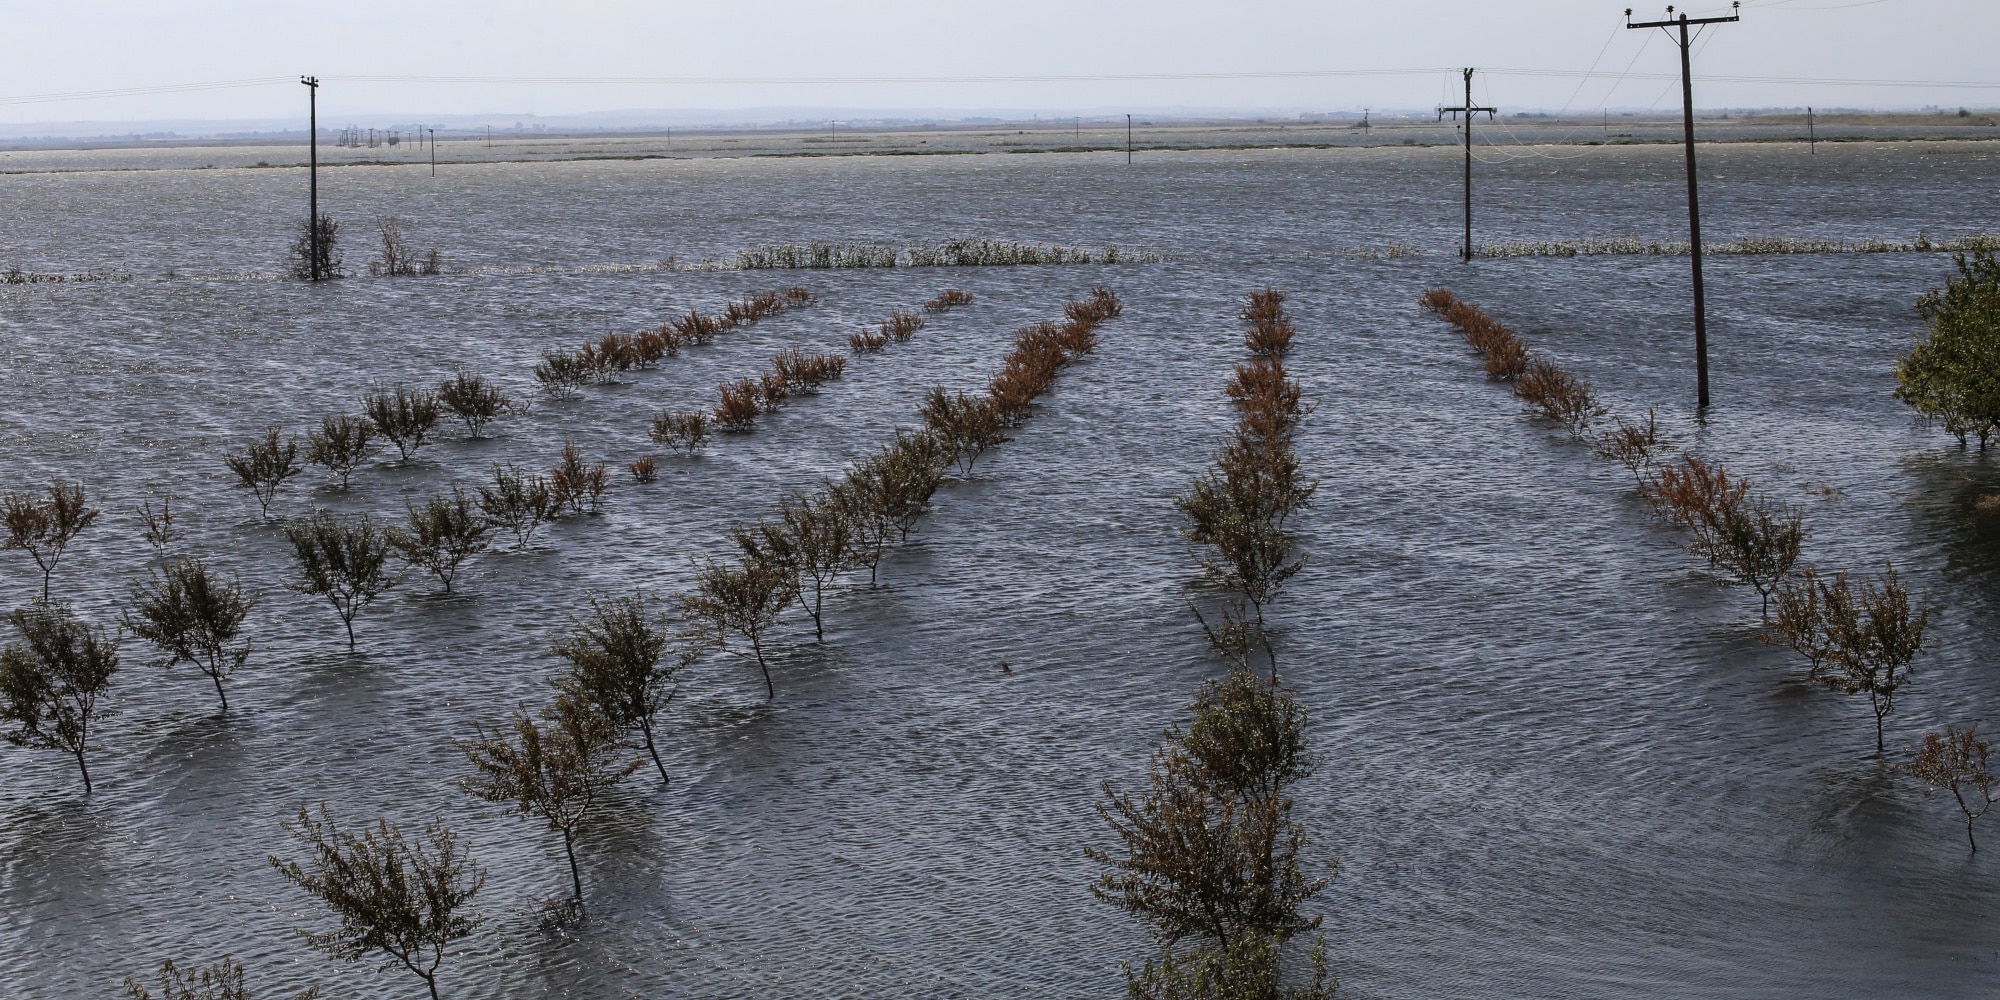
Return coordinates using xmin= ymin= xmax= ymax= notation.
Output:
xmin=0 ymin=144 xmax=2000 ymax=1000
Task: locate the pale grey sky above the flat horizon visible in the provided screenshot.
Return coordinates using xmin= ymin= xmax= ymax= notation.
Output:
xmin=0 ymin=0 xmax=2000 ymax=122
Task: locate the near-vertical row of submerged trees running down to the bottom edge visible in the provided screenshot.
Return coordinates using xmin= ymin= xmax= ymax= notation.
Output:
xmin=1088 ymin=288 xmax=1338 ymax=1000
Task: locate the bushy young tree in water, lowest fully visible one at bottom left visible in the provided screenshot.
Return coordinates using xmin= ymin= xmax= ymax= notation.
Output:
xmin=270 ymin=804 xmax=486 ymax=1000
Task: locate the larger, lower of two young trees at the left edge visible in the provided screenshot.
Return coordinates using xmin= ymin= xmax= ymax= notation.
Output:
xmin=0 ymin=604 xmax=118 ymax=796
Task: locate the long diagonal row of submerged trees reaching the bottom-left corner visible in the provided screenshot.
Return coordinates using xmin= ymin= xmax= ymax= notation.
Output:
xmin=39 ymin=288 xmax=1120 ymax=996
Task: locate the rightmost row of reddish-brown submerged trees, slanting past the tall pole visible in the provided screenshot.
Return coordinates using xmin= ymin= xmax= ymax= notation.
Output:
xmin=1420 ymin=288 xmax=2000 ymax=850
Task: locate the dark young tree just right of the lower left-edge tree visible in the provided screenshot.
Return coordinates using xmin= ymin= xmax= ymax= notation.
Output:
xmin=124 ymin=556 xmax=256 ymax=712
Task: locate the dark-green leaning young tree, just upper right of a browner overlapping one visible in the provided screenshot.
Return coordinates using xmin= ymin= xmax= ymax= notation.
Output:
xmin=550 ymin=594 xmax=696 ymax=784
